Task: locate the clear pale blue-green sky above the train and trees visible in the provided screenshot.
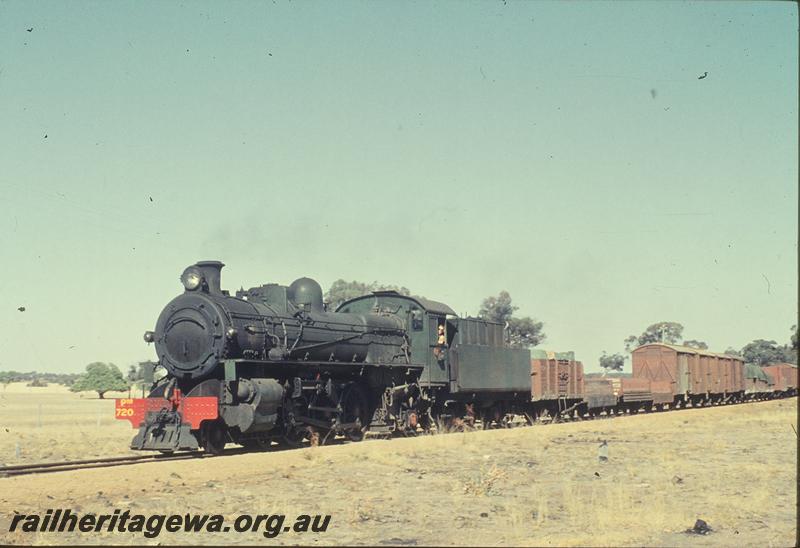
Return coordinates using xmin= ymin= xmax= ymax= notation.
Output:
xmin=0 ymin=1 xmax=798 ymax=371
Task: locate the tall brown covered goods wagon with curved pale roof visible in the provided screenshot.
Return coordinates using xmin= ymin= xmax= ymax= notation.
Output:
xmin=631 ymin=343 xmax=745 ymax=404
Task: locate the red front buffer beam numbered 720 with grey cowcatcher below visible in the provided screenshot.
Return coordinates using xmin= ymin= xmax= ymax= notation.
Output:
xmin=114 ymin=389 xmax=219 ymax=452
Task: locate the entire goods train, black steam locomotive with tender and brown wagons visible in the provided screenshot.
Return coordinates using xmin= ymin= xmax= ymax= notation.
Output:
xmin=116 ymin=261 xmax=797 ymax=454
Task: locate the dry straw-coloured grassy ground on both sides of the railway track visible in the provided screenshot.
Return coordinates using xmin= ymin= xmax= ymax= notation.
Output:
xmin=0 ymin=388 xmax=797 ymax=547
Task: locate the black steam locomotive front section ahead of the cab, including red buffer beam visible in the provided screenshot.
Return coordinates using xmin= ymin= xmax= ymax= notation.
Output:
xmin=116 ymin=261 xmax=422 ymax=453
